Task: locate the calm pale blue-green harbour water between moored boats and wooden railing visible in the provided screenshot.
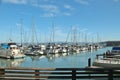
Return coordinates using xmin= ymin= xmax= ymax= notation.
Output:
xmin=0 ymin=47 xmax=111 ymax=68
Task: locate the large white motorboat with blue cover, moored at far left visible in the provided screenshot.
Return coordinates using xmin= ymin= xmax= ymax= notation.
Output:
xmin=0 ymin=42 xmax=25 ymax=59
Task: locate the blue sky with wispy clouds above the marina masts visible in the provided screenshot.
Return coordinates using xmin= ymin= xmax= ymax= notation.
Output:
xmin=0 ymin=0 xmax=120 ymax=42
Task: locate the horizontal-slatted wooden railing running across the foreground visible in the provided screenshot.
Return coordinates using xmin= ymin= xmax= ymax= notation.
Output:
xmin=0 ymin=67 xmax=120 ymax=80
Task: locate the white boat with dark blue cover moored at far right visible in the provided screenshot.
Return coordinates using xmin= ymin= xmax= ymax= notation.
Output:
xmin=93 ymin=47 xmax=120 ymax=68
